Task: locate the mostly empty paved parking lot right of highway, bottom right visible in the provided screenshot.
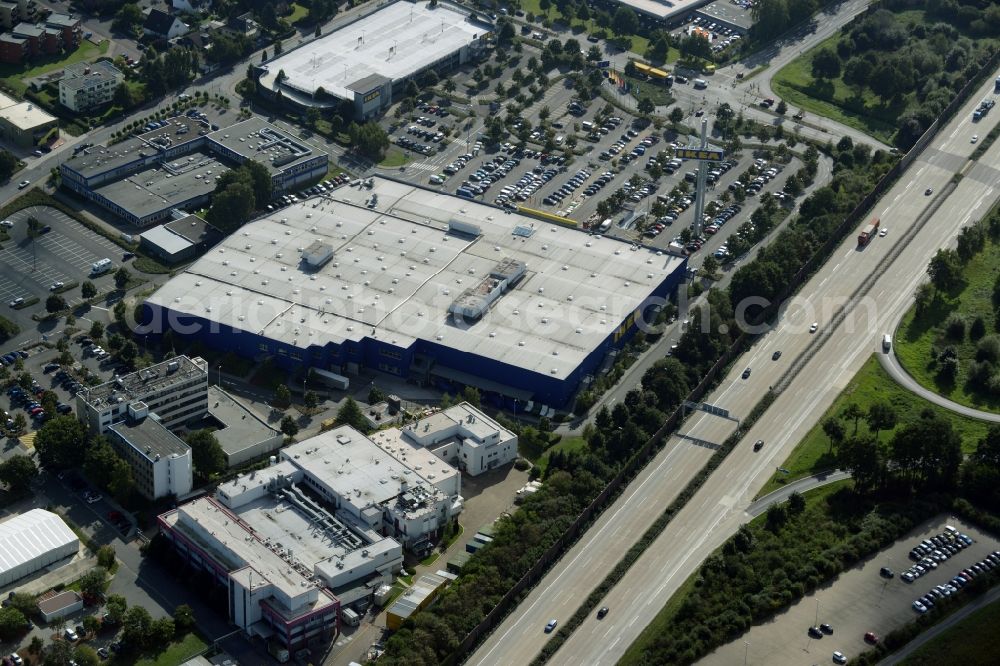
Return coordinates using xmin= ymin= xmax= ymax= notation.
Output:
xmin=701 ymin=516 xmax=1000 ymax=666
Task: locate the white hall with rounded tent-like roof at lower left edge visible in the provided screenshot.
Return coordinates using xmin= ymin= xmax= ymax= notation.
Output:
xmin=0 ymin=509 xmax=80 ymax=586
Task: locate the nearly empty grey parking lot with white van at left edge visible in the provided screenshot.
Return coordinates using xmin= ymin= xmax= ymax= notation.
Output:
xmin=0 ymin=207 xmax=122 ymax=319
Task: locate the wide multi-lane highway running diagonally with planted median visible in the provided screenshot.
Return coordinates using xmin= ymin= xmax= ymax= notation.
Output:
xmin=470 ymin=68 xmax=1000 ymax=665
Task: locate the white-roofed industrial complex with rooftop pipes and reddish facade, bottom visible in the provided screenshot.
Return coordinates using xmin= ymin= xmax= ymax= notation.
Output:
xmin=158 ymin=426 xmax=462 ymax=649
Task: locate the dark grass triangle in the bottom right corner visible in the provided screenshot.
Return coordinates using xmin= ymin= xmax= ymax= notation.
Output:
xmin=900 ymin=602 xmax=1000 ymax=666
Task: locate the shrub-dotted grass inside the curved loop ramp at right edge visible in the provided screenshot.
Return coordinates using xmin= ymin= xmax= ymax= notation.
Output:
xmin=893 ymin=232 xmax=1000 ymax=412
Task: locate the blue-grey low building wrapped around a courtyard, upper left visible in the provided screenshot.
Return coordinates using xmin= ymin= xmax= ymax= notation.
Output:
xmin=59 ymin=116 xmax=328 ymax=227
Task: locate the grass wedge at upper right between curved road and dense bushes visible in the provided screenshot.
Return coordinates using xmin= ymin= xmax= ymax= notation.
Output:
xmin=771 ymin=35 xmax=913 ymax=143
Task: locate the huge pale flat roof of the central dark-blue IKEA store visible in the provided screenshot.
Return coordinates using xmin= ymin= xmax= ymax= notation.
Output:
xmin=149 ymin=178 xmax=683 ymax=378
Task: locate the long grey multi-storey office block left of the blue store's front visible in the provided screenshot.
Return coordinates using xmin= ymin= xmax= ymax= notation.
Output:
xmin=76 ymin=356 xmax=208 ymax=435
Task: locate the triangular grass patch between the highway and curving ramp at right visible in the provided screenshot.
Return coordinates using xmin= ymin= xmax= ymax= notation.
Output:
xmin=758 ymin=355 xmax=988 ymax=497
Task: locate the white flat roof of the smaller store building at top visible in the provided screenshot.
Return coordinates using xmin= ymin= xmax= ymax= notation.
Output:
xmin=265 ymin=2 xmax=489 ymax=99
